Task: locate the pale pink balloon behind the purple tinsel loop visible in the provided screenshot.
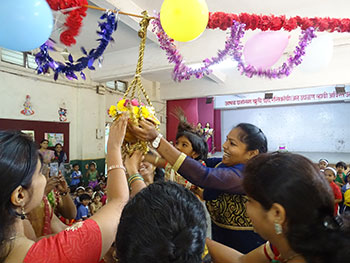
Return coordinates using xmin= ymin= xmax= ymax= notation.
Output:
xmin=243 ymin=31 xmax=289 ymax=69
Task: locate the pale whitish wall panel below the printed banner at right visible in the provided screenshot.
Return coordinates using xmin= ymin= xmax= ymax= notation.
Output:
xmin=221 ymin=102 xmax=350 ymax=163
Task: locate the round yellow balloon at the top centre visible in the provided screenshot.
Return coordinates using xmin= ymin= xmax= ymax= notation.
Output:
xmin=160 ymin=0 xmax=209 ymax=42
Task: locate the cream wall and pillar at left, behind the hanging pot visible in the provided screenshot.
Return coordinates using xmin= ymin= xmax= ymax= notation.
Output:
xmin=0 ymin=62 xmax=166 ymax=160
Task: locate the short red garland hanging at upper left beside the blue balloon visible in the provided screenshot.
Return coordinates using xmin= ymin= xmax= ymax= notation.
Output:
xmin=46 ymin=0 xmax=88 ymax=46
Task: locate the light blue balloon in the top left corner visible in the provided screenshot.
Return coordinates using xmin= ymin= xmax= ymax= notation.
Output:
xmin=0 ymin=0 xmax=53 ymax=51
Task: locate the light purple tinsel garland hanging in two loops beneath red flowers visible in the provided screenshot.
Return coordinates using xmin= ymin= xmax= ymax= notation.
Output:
xmin=152 ymin=15 xmax=316 ymax=82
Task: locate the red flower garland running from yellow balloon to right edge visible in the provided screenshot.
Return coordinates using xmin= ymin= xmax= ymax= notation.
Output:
xmin=207 ymin=12 xmax=350 ymax=33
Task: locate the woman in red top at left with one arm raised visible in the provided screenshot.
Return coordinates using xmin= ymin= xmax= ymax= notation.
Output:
xmin=0 ymin=116 xmax=129 ymax=263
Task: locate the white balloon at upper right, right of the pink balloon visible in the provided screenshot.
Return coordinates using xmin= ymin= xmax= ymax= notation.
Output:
xmin=298 ymin=33 xmax=334 ymax=72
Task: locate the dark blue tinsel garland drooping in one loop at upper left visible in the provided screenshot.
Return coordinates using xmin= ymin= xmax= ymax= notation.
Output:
xmin=35 ymin=12 xmax=118 ymax=80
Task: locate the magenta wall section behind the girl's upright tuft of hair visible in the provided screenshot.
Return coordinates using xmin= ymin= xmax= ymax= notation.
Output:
xmin=166 ymin=99 xmax=198 ymax=142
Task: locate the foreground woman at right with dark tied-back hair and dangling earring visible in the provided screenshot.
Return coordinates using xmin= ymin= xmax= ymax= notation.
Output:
xmin=207 ymin=153 xmax=350 ymax=263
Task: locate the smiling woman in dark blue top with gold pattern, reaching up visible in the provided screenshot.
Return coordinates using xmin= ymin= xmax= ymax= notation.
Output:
xmin=129 ymin=121 xmax=267 ymax=253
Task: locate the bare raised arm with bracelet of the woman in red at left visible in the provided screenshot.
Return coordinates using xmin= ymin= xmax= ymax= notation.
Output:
xmin=91 ymin=115 xmax=129 ymax=258
